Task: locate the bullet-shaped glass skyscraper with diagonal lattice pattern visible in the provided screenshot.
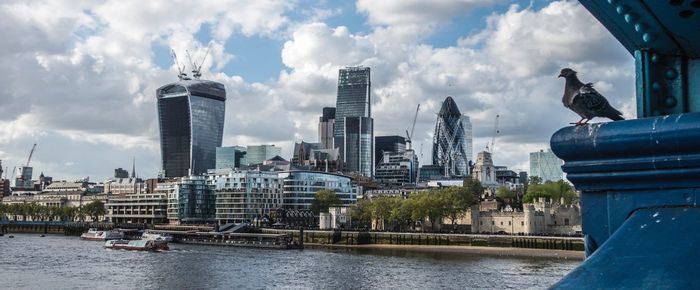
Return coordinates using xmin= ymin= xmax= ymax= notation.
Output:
xmin=433 ymin=96 xmax=470 ymax=176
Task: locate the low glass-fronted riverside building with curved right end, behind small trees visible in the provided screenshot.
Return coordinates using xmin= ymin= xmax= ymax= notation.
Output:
xmin=279 ymin=170 xmax=359 ymax=209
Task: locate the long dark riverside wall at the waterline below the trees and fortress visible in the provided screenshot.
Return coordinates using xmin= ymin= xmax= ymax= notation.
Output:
xmin=263 ymin=229 xmax=583 ymax=251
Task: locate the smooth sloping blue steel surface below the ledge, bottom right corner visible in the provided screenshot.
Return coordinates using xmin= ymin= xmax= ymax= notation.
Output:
xmin=552 ymin=207 xmax=700 ymax=289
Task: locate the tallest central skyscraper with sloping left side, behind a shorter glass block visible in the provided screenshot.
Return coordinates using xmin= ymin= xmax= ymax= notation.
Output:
xmin=333 ymin=66 xmax=372 ymax=161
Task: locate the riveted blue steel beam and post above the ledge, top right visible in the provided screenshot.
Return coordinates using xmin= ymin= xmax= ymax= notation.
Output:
xmin=580 ymin=0 xmax=700 ymax=117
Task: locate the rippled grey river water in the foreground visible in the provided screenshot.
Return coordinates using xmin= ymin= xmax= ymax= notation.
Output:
xmin=0 ymin=234 xmax=580 ymax=289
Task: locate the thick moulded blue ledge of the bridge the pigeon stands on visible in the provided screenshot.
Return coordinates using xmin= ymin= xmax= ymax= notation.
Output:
xmin=551 ymin=113 xmax=700 ymax=255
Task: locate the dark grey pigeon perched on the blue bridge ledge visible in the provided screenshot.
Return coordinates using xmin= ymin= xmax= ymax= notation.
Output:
xmin=559 ymin=68 xmax=625 ymax=126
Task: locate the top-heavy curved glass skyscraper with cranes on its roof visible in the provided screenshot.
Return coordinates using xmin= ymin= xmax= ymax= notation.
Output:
xmin=156 ymin=80 xmax=226 ymax=177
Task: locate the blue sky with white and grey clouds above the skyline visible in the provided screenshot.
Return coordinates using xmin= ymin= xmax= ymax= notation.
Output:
xmin=0 ymin=0 xmax=636 ymax=181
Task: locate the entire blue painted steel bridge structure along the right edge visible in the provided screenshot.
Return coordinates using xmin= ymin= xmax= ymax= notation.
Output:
xmin=551 ymin=0 xmax=700 ymax=289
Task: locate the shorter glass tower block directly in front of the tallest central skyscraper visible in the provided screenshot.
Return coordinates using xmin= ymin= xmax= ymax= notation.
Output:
xmin=343 ymin=117 xmax=374 ymax=177
